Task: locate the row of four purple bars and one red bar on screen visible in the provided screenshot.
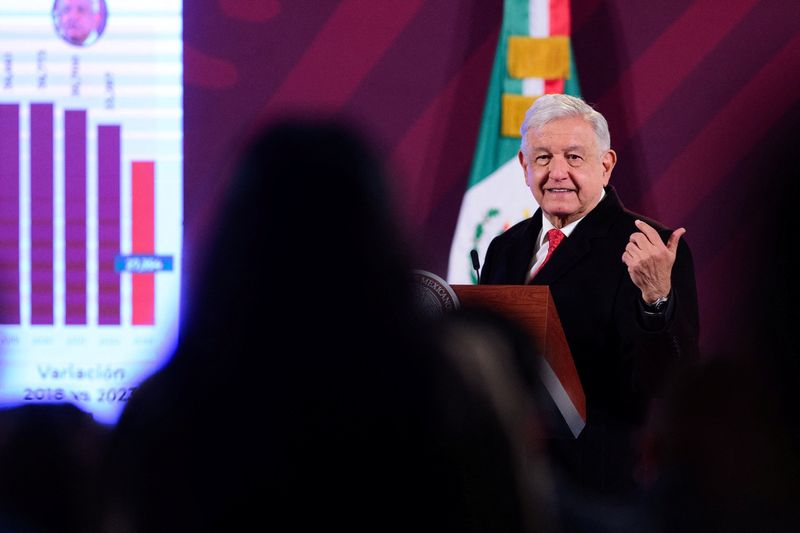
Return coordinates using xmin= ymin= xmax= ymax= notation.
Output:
xmin=0 ymin=103 xmax=164 ymax=325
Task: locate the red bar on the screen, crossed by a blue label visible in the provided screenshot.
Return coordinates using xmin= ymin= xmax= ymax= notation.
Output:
xmin=131 ymin=161 xmax=156 ymax=326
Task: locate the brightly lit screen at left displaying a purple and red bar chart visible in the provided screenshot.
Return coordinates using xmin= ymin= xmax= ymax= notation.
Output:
xmin=0 ymin=0 xmax=183 ymax=422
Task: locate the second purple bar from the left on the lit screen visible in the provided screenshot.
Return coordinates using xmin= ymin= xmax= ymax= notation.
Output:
xmin=31 ymin=104 xmax=53 ymax=325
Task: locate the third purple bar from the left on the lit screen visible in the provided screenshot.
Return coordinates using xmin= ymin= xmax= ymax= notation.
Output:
xmin=64 ymin=109 xmax=86 ymax=325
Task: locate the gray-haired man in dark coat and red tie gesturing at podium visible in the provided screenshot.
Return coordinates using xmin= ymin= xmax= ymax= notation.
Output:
xmin=481 ymin=94 xmax=699 ymax=496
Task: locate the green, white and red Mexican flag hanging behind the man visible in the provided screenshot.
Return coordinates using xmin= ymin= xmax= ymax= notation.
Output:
xmin=447 ymin=0 xmax=580 ymax=284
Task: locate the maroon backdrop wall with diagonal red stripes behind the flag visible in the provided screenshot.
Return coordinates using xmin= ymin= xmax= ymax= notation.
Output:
xmin=184 ymin=0 xmax=800 ymax=358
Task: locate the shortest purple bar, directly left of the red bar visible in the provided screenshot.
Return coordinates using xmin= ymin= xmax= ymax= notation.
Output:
xmin=97 ymin=126 xmax=122 ymax=325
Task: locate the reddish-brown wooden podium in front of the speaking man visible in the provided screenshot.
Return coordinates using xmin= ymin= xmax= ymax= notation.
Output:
xmin=450 ymin=285 xmax=586 ymax=438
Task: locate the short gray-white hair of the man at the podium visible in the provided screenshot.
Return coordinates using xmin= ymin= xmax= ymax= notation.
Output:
xmin=520 ymin=94 xmax=611 ymax=152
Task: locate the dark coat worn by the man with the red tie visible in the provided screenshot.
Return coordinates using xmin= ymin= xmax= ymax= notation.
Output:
xmin=481 ymin=187 xmax=699 ymax=493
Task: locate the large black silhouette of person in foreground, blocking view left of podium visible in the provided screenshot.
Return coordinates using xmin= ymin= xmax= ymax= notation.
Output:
xmin=101 ymin=121 xmax=556 ymax=531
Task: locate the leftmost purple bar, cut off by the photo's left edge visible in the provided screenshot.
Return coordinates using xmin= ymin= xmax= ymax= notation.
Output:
xmin=0 ymin=104 xmax=20 ymax=324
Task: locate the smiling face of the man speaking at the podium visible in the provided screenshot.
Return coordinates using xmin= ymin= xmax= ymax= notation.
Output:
xmin=519 ymin=117 xmax=617 ymax=228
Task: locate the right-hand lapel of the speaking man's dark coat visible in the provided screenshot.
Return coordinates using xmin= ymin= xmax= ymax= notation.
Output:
xmin=534 ymin=186 xmax=622 ymax=285
